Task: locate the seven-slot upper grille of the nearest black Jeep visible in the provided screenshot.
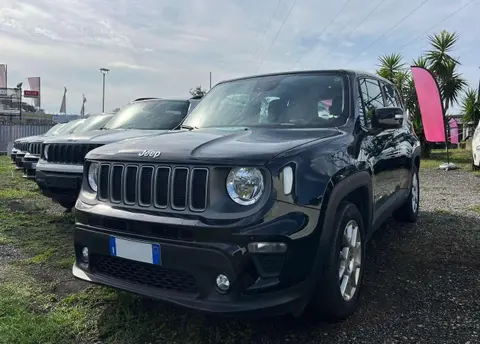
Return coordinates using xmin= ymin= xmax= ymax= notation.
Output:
xmin=98 ymin=163 xmax=208 ymax=212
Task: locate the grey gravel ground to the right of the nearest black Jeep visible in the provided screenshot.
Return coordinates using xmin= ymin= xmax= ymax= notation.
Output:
xmin=218 ymin=170 xmax=480 ymax=344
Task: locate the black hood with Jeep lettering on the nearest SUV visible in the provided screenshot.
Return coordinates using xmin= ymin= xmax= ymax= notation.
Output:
xmin=87 ymin=128 xmax=341 ymax=164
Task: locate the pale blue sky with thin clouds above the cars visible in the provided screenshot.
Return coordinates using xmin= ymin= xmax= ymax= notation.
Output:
xmin=0 ymin=0 xmax=480 ymax=113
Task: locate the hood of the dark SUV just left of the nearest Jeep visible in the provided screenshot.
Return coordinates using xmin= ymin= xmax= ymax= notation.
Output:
xmin=44 ymin=129 xmax=168 ymax=144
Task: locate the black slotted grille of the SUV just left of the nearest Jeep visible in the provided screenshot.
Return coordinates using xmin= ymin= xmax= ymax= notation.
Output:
xmin=41 ymin=143 xmax=101 ymax=164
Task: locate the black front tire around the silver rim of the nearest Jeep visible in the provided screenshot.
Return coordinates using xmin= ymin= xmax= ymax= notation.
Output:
xmin=310 ymin=202 xmax=365 ymax=322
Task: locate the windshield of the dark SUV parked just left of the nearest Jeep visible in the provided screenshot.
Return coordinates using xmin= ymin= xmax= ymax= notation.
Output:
xmin=105 ymin=99 xmax=189 ymax=130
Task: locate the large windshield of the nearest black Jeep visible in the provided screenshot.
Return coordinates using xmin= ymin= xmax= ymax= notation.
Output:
xmin=183 ymin=72 xmax=348 ymax=128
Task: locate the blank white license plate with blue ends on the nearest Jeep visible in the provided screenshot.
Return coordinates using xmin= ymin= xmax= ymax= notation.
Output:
xmin=110 ymin=236 xmax=162 ymax=265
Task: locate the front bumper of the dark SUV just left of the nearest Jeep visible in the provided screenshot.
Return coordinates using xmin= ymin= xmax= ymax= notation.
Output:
xmin=35 ymin=161 xmax=83 ymax=202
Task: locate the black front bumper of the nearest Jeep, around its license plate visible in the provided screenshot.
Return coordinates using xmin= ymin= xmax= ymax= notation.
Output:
xmin=72 ymin=200 xmax=318 ymax=315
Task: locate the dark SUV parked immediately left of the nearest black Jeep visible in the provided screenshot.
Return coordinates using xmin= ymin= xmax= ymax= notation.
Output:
xmin=35 ymin=98 xmax=198 ymax=210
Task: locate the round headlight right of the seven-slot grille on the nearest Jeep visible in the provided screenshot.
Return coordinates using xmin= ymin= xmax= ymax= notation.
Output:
xmin=226 ymin=167 xmax=265 ymax=205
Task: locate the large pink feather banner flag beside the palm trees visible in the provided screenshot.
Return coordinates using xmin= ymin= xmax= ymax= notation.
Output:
xmin=411 ymin=66 xmax=445 ymax=142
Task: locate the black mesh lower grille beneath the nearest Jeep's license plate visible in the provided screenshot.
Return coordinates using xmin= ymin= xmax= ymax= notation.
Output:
xmin=90 ymin=255 xmax=198 ymax=294
